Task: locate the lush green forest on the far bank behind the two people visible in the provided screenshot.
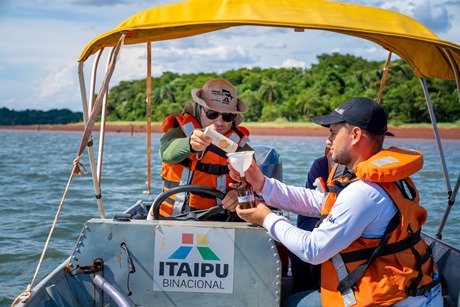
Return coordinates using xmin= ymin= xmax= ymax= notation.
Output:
xmin=107 ymin=53 xmax=460 ymax=125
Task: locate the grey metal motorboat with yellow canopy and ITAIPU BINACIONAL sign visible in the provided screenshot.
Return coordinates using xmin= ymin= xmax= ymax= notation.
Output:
xmin=13 ymin=0 xmax=460 ymax=306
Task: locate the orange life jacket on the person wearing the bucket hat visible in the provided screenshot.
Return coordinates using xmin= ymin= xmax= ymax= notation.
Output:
xmin=160 ymin=113 xmax=249 ymax=216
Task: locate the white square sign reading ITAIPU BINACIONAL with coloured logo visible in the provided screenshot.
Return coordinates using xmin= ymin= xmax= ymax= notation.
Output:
xmin=153 ymin=227 xmax=235 ymax=293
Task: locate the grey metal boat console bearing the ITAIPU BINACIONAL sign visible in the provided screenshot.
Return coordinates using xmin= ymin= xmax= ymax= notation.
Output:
xmin=24 ymin=219 xmax=281 ymax=306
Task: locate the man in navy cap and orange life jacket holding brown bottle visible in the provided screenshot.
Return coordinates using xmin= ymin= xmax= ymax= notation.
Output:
xmin=227 ymin=97 xmax=443 ymax=306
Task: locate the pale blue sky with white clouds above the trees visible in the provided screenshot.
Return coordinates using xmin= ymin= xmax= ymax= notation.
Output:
xmin=0 ymin=0 xmax=460 ymax=111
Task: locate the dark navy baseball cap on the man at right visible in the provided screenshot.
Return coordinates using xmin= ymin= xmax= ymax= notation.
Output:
xmin=311 ymin=97 xmax=394 ymax=136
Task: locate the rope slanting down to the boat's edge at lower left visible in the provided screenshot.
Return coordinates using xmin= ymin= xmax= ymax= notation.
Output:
xmin=11 ymin=157 xmax=84 ymax=306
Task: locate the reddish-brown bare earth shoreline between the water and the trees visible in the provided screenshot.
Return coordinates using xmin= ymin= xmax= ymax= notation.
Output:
xmin=0 ymin=123 xmax=460 ymax=140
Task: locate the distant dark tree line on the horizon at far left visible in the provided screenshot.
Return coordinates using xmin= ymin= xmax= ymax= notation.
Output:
xmin=0 ymin=108 xmax=83 ymax=126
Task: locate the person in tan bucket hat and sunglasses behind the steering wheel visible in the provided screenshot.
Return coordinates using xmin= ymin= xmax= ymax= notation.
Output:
xmin=160 ymin=78 xmax=252 ymax=220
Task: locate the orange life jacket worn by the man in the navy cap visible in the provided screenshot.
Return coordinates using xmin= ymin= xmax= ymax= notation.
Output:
xmin=321 ymin=147 xmax=438 ymax=306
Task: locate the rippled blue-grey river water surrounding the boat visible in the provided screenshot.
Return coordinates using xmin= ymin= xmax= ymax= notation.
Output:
xmin=0 ymin=130 xmax=460 ymax=306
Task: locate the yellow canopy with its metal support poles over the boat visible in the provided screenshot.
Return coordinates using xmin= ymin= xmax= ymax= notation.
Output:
xmin=73 ymin=0 xmax=460 ymax=231
